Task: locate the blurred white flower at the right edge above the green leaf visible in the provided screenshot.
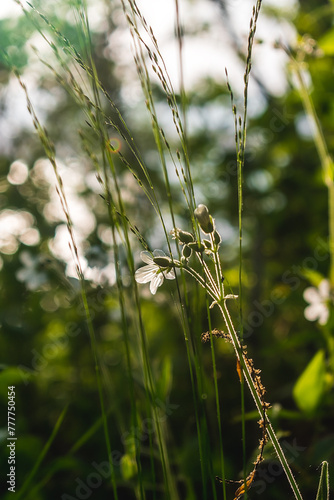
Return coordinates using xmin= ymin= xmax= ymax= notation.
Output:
xmin=303 ymin=280 xmax=332 ymax=325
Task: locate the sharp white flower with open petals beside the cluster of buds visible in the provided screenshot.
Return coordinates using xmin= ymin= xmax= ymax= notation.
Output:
xmin=135 ymin=250 xmax=175 ymax=295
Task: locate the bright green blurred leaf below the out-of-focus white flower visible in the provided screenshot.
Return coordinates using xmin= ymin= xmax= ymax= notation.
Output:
xmin=293 ymin=349 xmax=326 ymax=413
